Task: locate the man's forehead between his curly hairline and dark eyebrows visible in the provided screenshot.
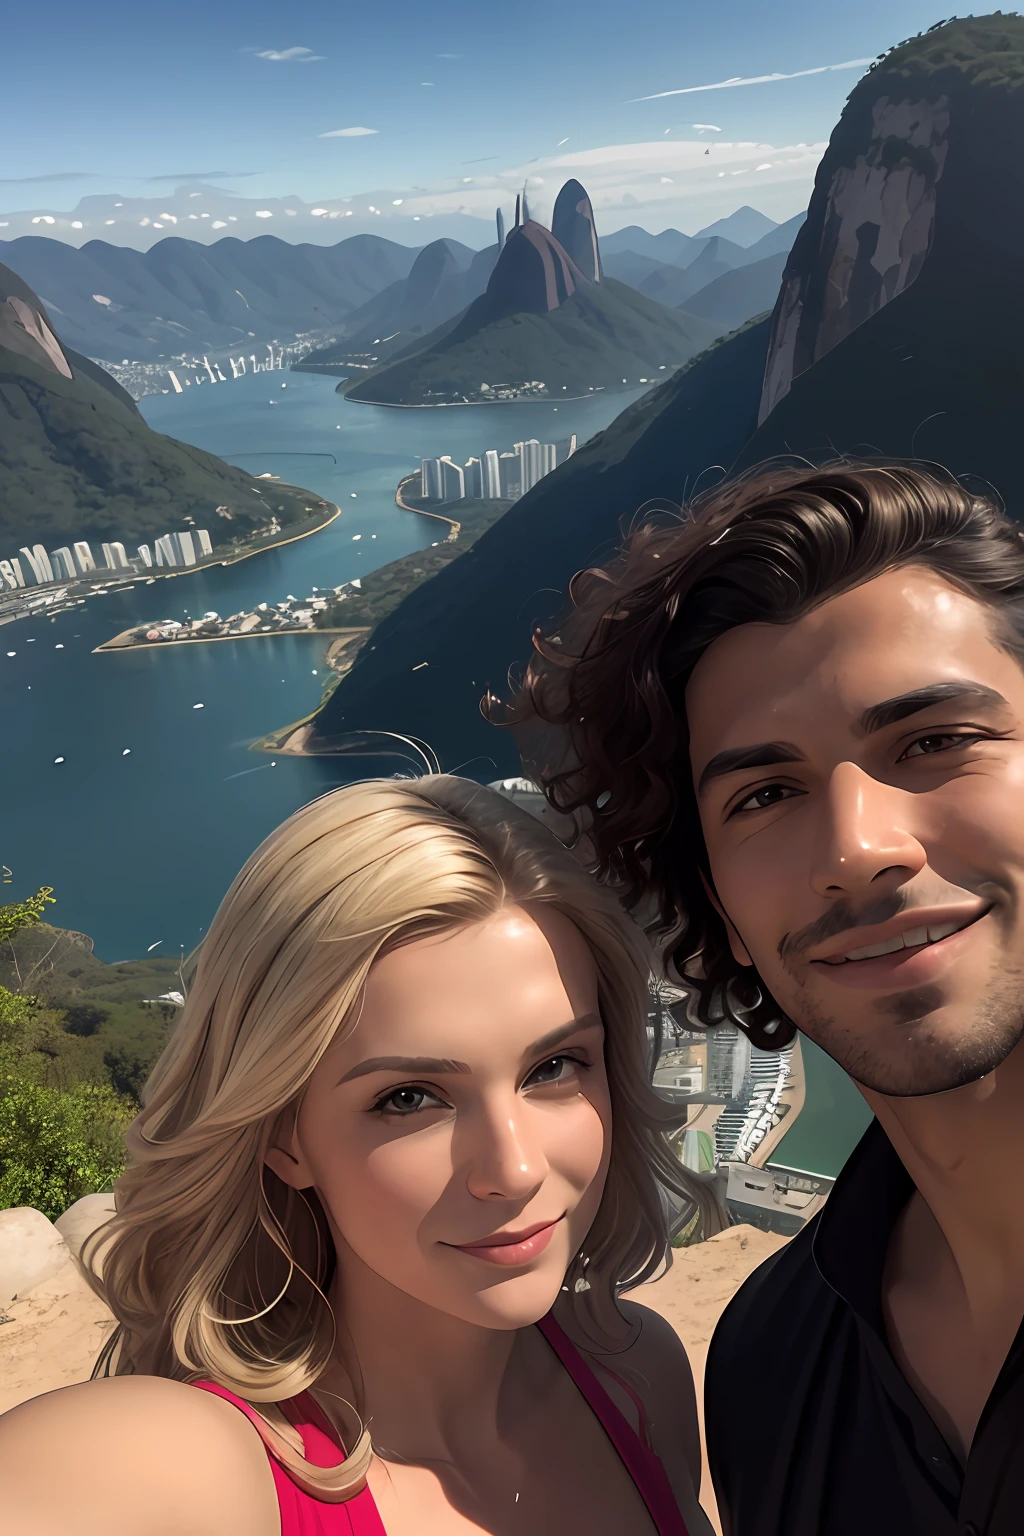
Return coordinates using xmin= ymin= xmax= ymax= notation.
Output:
xmin=686 ymin=567 xmax=1009 ymax=751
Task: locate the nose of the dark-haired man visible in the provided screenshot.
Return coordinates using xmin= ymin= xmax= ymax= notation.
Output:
xmin=811 ymin=762 xmax=927 ymax=897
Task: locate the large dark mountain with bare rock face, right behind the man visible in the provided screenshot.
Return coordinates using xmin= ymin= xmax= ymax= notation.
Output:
xmin=306 ymin=15 xmax=1024 ymax=779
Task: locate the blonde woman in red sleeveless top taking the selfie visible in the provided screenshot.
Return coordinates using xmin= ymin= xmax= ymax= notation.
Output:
xmin=0 ymin=776 xmax=711 ymax=1536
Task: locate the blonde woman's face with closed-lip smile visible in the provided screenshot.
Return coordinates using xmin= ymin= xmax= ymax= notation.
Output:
xmin=267 ymin=906 xmax=611 ymax=1329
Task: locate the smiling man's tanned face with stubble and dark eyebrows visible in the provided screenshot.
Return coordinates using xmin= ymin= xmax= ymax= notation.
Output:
xmin=686 ymin=565 xmax=1024 ymax=1097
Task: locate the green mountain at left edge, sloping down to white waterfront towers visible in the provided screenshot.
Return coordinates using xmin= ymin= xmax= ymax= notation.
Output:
xmin=0 ymin=266 xmax=324 ymax=559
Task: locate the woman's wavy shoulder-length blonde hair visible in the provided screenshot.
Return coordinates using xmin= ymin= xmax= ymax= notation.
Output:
xmin=83 ymin=774 xmax=717 ymax=1501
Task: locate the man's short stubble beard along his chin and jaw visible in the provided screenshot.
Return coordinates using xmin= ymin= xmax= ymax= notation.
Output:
xmin=773 ymin=969 xmax=1024 ymax=1098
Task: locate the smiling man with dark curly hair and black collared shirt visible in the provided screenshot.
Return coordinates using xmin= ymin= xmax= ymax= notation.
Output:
xmin=517 ymin=462 xmax=1024 ymax=1536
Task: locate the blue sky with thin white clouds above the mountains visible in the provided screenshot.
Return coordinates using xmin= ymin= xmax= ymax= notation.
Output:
xmin=0 ymin=0 xmax=964 ymax=244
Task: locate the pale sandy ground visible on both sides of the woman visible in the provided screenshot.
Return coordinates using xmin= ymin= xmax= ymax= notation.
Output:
xmin=0 ymin=1227 xmax=786 ymax=1530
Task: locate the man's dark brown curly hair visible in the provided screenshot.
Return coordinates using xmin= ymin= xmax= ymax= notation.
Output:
xmin=497 ymin=459 xmax=1024 ymax=1049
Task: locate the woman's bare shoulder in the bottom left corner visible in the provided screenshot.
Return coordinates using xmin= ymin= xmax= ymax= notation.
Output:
xmin=0 ymin=1376 xmax=281 ymax=1536
